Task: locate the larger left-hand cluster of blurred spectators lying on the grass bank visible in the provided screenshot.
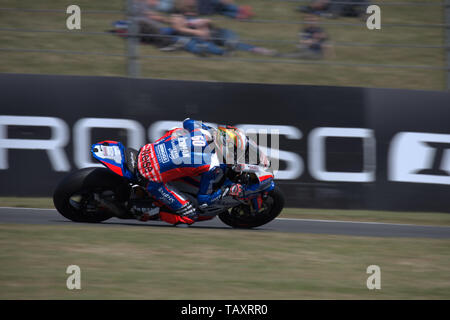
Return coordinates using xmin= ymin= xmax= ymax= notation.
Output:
xmin=129 ymin=0 xmax=276 ymax=56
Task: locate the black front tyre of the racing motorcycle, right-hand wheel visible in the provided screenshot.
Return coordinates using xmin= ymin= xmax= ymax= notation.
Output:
xmin=218 ymin=187 xmax=284 ymax=229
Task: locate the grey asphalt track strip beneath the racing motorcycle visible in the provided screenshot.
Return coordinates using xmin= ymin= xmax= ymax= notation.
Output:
xmin=0 ymin=207 xmax=450 ymax=239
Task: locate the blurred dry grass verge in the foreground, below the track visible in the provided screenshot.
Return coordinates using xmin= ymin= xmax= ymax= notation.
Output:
xmin=0 ymin=225 xmax=450 ymax=300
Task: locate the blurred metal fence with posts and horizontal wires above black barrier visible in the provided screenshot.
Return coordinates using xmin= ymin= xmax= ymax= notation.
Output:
xmin=0 ymin=0 xmax=450 ymax=90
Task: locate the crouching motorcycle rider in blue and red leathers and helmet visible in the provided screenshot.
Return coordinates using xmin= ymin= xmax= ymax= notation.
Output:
xmin=138 ymin=118 xmax=253 ymax=225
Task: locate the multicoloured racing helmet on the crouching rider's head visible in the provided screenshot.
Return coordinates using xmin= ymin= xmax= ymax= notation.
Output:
xmin=214 ymin=126 xmax=248 ymax=164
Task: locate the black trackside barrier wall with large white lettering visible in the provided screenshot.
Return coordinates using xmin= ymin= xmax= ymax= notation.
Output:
xmin=0 ymin=74 xmax=450 ymax=212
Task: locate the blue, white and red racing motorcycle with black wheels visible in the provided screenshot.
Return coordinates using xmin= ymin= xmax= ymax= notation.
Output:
xmin=53 ymin=141 xmax=284 ymax=228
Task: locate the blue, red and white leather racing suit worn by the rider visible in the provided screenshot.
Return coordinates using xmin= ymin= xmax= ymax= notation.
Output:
xmin=138 ymin=119 xmax=232 ymax=224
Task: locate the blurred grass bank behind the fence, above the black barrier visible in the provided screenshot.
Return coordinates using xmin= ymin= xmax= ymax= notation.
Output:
xmin=0 ymin=0 xmax=447 ymax=90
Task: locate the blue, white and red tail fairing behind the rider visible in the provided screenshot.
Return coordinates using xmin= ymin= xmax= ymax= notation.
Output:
xmin=91 ymin=140 xmax=133 ymax=179
